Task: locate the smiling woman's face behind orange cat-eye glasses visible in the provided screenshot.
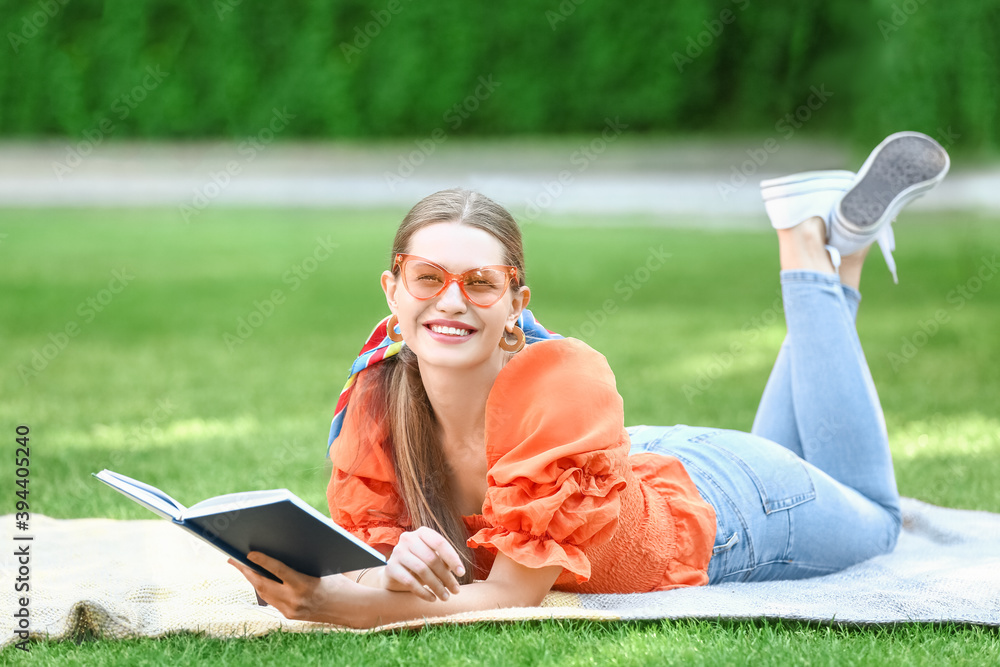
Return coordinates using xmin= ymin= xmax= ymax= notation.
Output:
xmin=382 ymin=222 xmax=530 ymax=368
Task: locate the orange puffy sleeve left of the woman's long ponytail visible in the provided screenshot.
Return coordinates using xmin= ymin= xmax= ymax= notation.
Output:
xmin=326 ymin=371 xmax=409 ymax=552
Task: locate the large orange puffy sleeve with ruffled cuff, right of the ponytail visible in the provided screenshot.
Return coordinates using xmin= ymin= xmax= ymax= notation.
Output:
xmin=469 ymin=339 xmax=629 ymax=583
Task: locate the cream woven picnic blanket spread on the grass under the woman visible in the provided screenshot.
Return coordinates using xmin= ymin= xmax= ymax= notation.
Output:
xmin=0 ymin=498 xmax=1000 ymax=645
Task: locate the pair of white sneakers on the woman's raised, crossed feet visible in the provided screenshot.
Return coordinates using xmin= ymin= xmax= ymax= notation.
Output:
xmin=760 ymin=132 xmax=950 ymax=283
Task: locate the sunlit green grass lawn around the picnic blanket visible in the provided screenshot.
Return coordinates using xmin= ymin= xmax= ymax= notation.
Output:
xmin=0 ymin=209 xmax=1000 ymax=665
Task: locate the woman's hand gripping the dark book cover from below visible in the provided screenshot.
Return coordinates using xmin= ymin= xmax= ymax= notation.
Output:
xmin=229 ymin=551 xmax=346 ymax=623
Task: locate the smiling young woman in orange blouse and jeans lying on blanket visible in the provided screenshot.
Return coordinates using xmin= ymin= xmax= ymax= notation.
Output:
xmin=230 ymin=133 xmax=948 ymax=627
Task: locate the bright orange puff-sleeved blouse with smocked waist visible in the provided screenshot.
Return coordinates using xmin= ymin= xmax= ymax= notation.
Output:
xmin=327 ymin=338 xmax=715 ymax=593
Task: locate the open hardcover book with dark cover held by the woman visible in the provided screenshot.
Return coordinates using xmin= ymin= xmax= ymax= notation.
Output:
xmin=94 ymin=470 xmax=385 ymax=581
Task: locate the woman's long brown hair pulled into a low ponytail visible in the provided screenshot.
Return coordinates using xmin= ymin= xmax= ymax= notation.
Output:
xmin=366 ymin=189 xmax=525 ymax=583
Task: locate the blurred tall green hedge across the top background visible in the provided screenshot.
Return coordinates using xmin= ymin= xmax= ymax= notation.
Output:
xmin=0 ymin=0 xmax=1000 ymax=148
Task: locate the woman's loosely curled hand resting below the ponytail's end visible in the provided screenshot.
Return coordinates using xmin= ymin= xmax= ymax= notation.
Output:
xmin=384 ymin=527 xmax=465 ymax=602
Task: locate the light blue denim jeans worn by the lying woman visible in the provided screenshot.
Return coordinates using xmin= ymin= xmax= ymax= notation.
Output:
xmin=628 ymin=271 xmax=901 ymax=584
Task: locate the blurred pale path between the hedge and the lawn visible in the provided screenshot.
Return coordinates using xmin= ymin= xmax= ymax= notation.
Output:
xmin=0 ymin=140 xmax=1000 ymax=226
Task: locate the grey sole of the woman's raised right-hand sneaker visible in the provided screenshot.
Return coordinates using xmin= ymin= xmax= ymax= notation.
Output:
xmin=836 ymin=132 xmax=950 ymax=234
